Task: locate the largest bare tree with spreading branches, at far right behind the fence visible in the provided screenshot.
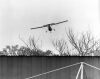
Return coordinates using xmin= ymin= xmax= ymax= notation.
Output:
xmin=67 ymin=29 xmax=100 ymax=56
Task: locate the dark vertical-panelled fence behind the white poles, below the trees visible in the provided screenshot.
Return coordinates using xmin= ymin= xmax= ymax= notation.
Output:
xmin=0 ymin=57 xmax=100 ymax=79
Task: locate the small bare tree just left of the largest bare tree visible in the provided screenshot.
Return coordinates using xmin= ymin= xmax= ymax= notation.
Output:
xmin=52 ymin=39 xmax=70 ymax=56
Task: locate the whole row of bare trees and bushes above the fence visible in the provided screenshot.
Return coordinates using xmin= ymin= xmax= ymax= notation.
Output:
xmin=0 ymin=28 xmax=100 ymax=56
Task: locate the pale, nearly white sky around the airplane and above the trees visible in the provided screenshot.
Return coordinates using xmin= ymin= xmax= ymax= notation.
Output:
xmin=0 ymin=0 xmax=100 ymax=50
